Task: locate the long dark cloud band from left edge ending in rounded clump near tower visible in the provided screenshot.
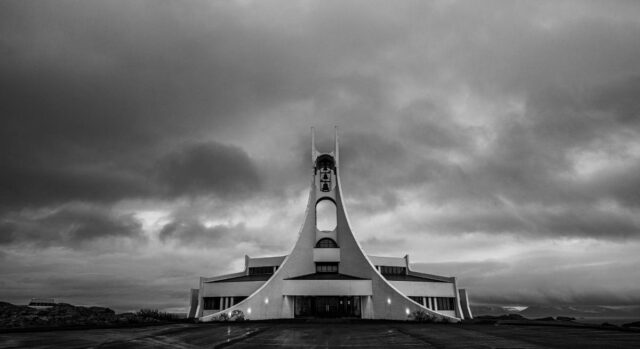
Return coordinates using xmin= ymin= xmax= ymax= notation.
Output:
xmin=0 ymin=141 xmax=260 ymax=209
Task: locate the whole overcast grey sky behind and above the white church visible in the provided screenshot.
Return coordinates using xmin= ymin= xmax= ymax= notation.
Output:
xmin=0 ymin=0 xmax=640 ymax=311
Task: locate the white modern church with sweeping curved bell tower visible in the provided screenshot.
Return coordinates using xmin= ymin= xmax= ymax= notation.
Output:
xmin=188 ymin=129 xmax=472 ymax=322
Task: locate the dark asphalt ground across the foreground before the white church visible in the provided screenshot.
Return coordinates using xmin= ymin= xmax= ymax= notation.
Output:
xmin=0 ymin=321 xmax=640 ymax=348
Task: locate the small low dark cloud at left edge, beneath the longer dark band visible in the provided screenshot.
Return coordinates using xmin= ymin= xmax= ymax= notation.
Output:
xmin=0 ymin=204 xmax=142 ymax=248
